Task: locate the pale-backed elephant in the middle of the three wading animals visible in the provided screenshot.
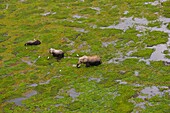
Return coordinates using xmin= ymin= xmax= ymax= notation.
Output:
xmin=49 ymin=48 xmax=64 ymax=60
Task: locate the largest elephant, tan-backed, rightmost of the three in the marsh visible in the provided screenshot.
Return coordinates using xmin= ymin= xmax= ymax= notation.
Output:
xmin=77 ymin=55 xmax=102 ymax=68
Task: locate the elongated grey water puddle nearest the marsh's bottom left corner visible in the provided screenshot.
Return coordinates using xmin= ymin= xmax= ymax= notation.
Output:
xmin=7 ymin=90 xmax=37 ymax=106
